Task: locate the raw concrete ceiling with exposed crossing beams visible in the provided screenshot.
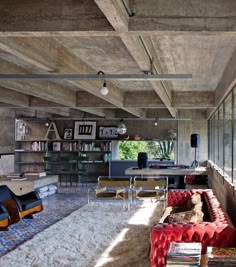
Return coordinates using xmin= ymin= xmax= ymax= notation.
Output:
xmin=0 ymin=0 xmax=236 ymax=118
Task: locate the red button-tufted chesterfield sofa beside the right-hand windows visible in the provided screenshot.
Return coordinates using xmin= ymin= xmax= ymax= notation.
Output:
xmin=150 ymin=189 xmax=236 ymax=267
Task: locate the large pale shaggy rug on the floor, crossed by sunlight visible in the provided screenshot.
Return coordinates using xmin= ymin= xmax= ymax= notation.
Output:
xmin=0 ymin=202 xmax=162 ymax=267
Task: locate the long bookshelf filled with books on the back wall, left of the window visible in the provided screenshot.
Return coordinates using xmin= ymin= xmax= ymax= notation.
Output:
xmin=15 ymin=121 xmax=111 ymax=182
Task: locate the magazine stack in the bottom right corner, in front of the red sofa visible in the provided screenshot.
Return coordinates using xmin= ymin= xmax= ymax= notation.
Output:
xmin=207 ymin=247 xmax=236 ymax=267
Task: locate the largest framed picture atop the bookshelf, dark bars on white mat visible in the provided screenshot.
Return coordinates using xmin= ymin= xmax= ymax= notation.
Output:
xmin=74 ymin=121 xmax=96 ymax=139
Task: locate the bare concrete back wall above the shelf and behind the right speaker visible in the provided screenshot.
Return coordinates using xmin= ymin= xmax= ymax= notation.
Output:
xmin=17 ymin=117 xmax=208 ymax=165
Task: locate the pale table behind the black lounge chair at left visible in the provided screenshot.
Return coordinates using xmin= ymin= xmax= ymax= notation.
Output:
xmin=0 ymin=175 xmax=58 ymax=196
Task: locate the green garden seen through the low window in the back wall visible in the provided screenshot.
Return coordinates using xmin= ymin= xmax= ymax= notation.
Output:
xmin=119 ymin=140 xmax=175 ymax=160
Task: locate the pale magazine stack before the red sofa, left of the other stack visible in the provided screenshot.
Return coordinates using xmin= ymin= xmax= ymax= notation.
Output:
xmin=166 ymin=242 xmax=202 ymax=267
